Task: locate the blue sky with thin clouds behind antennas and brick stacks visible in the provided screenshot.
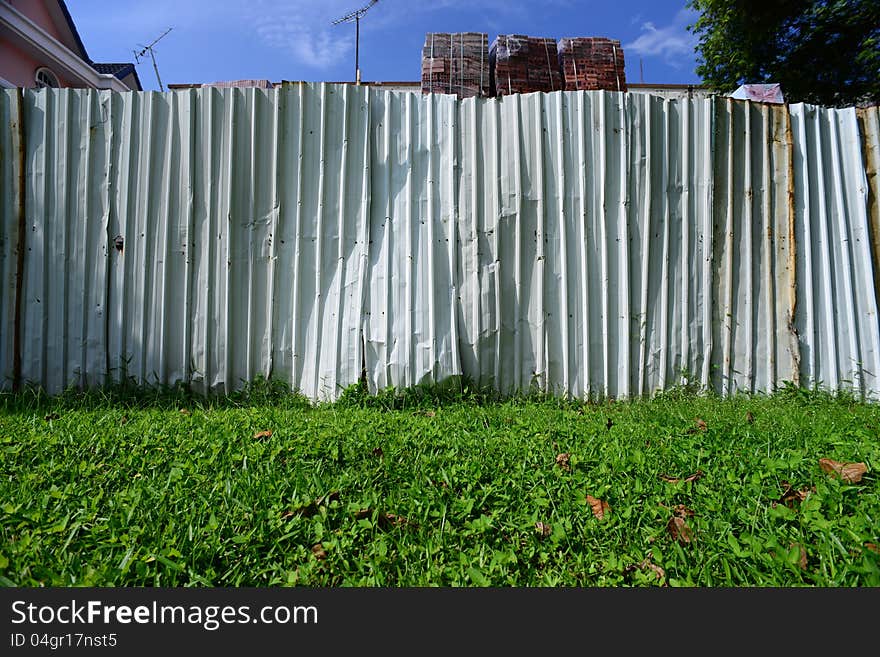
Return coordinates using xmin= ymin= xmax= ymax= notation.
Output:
xmin=67 ymin=0 xmax=699 ymax=89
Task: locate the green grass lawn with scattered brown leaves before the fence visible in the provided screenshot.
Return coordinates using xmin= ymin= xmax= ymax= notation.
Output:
xmin=0 ymin=385 xmax=880 ymax=587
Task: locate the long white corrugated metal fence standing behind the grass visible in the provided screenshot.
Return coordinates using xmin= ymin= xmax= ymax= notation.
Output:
xmin=0 ymin=84 xmax=880 ymax=399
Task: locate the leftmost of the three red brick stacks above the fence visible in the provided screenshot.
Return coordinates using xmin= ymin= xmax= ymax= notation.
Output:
xmin=422 ymin=32 xmax=489 ymax=98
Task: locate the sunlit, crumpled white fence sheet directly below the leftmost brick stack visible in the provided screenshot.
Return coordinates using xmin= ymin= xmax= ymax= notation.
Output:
xmin=363 ymin=91 xmax=461 ymax=390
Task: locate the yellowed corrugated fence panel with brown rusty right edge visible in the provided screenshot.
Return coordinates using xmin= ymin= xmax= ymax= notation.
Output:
xmin=707 ymin=99 xmax=799 ymax=394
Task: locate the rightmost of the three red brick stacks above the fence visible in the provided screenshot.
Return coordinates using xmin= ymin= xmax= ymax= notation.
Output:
xmin=559 ymin=37 xmax=626 ymax=91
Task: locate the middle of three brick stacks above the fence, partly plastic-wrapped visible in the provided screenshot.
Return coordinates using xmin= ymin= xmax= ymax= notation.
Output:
xmin=489 ymin=34 xmax=563 ymax=96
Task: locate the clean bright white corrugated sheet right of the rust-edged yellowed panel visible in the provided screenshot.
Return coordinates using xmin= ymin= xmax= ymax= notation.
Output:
xmin=791 ymin=104 xmax=880 ymax=397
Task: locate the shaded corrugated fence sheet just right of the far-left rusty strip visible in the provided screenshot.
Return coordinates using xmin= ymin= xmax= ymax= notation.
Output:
xmin=20 ymin=90 xmax=111 ymax=391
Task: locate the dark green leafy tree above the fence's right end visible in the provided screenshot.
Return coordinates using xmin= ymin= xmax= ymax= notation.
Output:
xmin=688 ymin=0 xmax=880 ymax=106
